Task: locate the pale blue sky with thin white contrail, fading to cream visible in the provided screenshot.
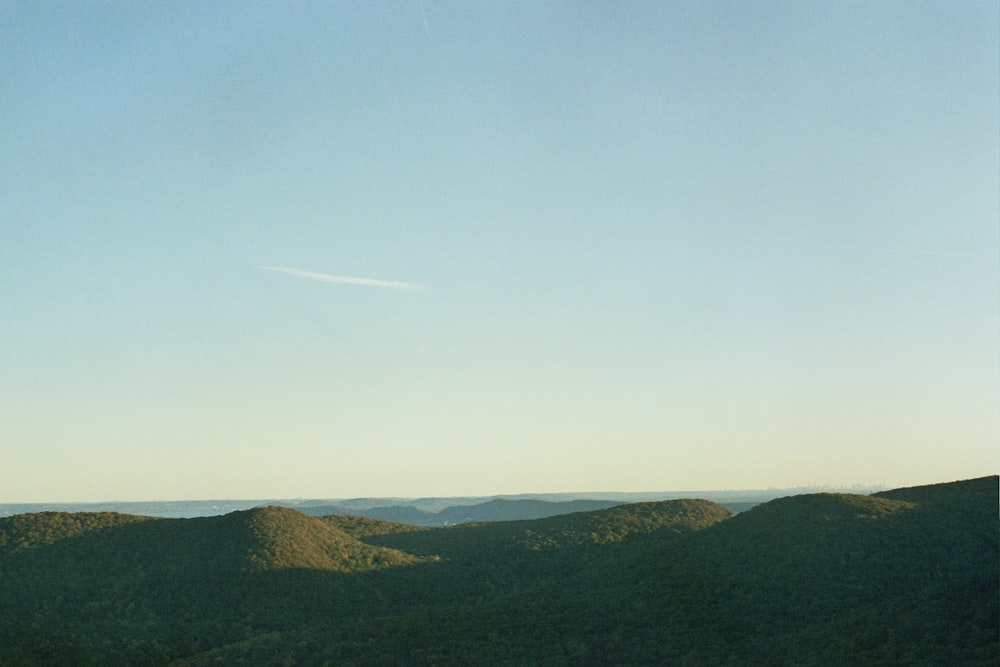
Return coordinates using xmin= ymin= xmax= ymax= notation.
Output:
xmin=0 ymin=0 xmax=1000 ymax=502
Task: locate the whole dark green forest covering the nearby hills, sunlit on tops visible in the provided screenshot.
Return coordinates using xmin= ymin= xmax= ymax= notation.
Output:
xmin=0 ymin=476 xmax=1000 ymax=666
